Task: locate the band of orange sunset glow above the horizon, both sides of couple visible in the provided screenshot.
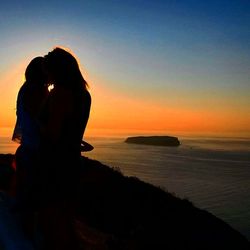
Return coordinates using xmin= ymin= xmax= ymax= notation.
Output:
xmin=0 ymin=60 xmax=250 ymax=139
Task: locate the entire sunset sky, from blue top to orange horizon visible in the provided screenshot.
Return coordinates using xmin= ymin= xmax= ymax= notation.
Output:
xmin=0 ymin=0 xmax=250 ymax=136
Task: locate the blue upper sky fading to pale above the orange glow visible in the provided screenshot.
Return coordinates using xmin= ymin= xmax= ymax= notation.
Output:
xmin=0 ymin=0 xmax=250 ymax=136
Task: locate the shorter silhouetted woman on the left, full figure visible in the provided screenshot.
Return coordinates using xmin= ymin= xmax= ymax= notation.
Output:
xmin=12 ymin=57 xmax=49 ymax=238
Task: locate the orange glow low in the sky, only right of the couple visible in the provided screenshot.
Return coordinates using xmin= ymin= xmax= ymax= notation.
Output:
xmin=84 ymin=79 xmax=250 ymax=138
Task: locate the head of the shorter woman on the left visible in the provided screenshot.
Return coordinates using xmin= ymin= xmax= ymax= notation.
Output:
xmin=25 ymin=56 xmax=48 ymax=85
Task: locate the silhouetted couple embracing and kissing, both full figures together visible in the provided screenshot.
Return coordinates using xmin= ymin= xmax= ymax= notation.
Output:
xmin=13 ymin=48 xmax=91 ymax=250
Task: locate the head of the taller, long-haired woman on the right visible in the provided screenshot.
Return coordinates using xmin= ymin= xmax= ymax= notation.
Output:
xmin=45 ymin=47 xmax=87 ymax=89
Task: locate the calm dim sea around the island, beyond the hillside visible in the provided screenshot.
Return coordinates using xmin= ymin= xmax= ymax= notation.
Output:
xmin=0 ymin=137 xmax=250 ymax=240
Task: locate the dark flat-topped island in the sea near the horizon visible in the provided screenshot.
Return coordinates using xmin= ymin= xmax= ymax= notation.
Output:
xmin=125 ymin=136 xmax=180 ymax=147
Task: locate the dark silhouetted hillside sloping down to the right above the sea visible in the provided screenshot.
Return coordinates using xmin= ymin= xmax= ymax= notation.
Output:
xmin=0 ymin=155 xmax=250 ymax=250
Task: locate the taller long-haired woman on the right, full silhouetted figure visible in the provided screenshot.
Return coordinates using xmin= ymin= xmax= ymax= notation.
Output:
xmin=37 ymin=48 xmax=91 ymax=249
